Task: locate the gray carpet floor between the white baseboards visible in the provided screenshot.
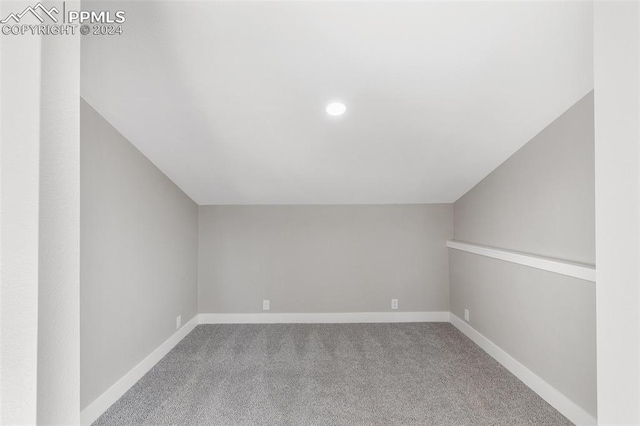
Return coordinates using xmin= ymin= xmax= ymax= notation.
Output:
xmin=94 ymin=323 xmax=571 ymax=425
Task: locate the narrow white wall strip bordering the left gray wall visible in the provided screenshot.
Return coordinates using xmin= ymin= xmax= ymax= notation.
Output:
xmin=37 ymin=15 xmax=80 ymax=425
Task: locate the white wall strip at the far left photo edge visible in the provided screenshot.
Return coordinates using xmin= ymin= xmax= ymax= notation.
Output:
xmin=0 ymin=15 xmax=41 ymax=425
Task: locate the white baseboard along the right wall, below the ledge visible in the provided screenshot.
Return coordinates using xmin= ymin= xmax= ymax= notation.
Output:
xmin=451 ymin=313 xmax=597 ymax=425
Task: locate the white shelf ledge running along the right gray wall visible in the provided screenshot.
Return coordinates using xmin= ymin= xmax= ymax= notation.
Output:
xmin=447 ymin=240 xmax=596 ymax=282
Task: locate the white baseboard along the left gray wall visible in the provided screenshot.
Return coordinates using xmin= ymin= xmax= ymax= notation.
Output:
xmin=80 ymin=315 xmax=198 ymax=426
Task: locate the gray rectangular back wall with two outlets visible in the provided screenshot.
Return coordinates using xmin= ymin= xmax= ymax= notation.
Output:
xmin=199 ymin=204 xmax=453 ymax=313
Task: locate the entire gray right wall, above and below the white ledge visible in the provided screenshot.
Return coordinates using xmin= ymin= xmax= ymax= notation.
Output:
xmin=449 ymin=93 xmax=596 ymax=416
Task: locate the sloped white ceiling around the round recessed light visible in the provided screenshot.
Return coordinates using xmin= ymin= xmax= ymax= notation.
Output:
xmin=81 ymin=1 xmax=593 ymax=204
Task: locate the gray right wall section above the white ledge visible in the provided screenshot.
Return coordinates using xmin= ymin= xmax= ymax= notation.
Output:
xmin=454 ymin=92 xmax=595 ymax=265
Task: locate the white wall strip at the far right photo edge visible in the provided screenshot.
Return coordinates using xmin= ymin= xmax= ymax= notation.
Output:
xmin=594 ymin=1 xmax=640 ymax=425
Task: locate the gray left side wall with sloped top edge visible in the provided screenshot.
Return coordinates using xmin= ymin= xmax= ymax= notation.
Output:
xmin=80 ymin=100 xmax=198 ymax=408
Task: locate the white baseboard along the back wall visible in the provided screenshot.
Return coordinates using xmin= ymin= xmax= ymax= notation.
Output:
xmin=199 ymin=312 xmax=449 ymax=324
